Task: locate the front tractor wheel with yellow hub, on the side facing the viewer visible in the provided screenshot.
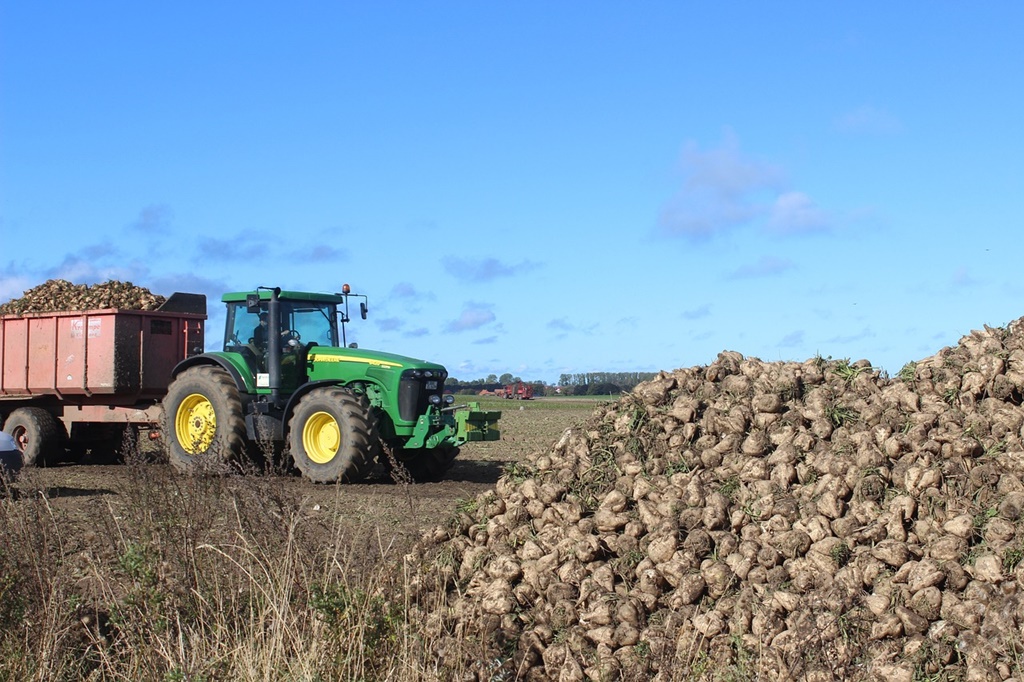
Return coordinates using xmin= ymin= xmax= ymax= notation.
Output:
xmin=288 ymin=387 xmax=380 ymax=483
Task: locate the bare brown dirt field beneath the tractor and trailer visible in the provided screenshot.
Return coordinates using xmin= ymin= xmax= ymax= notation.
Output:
xmin=9 ymin=398 xmax=599 ymax=569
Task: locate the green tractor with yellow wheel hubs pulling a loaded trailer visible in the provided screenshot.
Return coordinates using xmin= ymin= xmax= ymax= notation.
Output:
xmin=163 ymin=285 xmax=501 ymax=482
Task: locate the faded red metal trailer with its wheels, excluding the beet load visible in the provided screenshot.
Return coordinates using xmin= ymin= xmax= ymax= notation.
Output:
xmin=0 ymin=294 xmax=206 ymax=465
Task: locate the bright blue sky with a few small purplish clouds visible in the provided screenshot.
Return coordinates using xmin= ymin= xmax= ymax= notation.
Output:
xmin=0 ymin=0 xmax=1024 ymax=381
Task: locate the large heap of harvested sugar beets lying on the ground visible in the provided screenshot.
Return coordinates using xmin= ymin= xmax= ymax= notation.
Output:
xmin=407 ymin=318 xmax=1024 ymax=682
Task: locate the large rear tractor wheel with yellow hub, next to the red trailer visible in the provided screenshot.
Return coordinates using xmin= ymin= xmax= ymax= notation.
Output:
xmin=164 ymin=365 xmax=246 ymax=473
